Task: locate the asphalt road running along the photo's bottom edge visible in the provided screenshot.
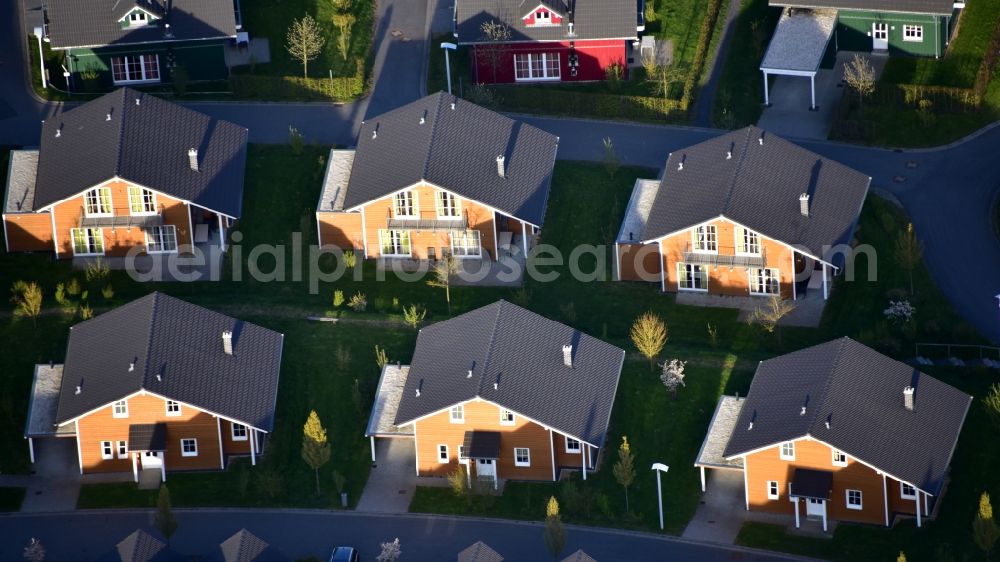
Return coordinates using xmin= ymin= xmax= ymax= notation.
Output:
xmin=0 ymin=510 xmax=803 ymax=562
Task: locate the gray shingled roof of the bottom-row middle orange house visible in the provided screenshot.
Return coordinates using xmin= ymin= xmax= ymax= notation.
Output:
xmin=396 ymin=300 xmax=625 ymax=446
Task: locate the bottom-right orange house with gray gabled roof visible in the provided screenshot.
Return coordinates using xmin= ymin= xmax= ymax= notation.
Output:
xmin=695 ymin=337 xmax=972 ymax=531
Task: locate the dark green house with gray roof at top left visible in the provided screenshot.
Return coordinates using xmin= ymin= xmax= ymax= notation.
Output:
xmin=40 ymin=0 xmax=242 ymax=87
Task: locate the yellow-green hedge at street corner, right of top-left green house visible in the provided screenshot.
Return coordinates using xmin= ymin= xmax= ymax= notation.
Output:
xmin=229 ymin=58 xmax=365 ymax=101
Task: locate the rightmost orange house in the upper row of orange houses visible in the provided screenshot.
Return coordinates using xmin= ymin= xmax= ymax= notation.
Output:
xmin=615 ymin=127 xmax=871 ymax=300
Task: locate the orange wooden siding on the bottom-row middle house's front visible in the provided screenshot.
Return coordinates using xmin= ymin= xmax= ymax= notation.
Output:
xmin=414 ymin=401 xmax=559 ymax=480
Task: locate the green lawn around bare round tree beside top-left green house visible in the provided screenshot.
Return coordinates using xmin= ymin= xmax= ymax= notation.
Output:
xmin=240 ymin=0 xmax=375 ymax=78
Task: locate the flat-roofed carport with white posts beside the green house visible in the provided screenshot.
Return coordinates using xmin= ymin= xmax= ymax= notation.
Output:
xmin=760 ymin=8 xmax=837 ymax=111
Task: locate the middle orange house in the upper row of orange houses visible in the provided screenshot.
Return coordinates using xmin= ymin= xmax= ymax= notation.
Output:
xmin=316 ymin=92 xmax=559 ymax=262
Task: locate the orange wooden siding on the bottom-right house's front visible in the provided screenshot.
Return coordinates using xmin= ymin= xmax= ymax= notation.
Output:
xmin=744 ymin=439 xmax=891 ymax=525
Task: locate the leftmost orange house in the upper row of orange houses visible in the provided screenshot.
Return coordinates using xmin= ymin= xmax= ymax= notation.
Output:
xmin=3 ymin=88 xmax=247 ymax=259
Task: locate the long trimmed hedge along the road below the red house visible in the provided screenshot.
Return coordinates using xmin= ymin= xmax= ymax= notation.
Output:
xmin=493 ymin=86 xmax=684 ymax=121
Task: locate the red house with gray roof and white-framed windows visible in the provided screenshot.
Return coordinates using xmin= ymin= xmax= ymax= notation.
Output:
xmin=455 ymin=0 xmax=639 ymax=84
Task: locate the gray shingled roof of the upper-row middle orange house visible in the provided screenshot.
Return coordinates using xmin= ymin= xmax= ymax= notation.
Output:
xmin=344 ymin=92 xmax=559 ymax=226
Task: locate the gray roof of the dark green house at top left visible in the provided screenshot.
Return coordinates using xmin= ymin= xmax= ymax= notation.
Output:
xmin=45 ymin=0 xmax=236 ymax=49
